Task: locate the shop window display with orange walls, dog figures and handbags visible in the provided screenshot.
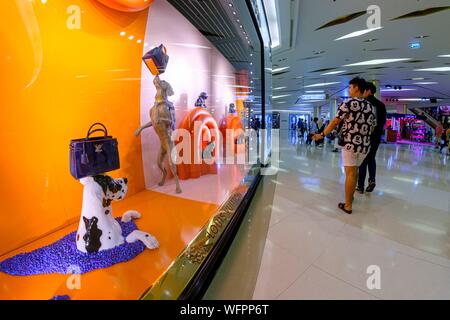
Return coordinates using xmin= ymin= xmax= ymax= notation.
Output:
xmin=0 ymin=0 xmax=266 ymax=300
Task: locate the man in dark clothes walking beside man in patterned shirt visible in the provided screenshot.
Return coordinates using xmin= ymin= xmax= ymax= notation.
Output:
xmin=356 ymin=82 xmax=386 ymax=194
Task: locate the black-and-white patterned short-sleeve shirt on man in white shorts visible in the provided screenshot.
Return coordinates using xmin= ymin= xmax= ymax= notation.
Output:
xmin=336 ymin=98 xmax=376 ymax=153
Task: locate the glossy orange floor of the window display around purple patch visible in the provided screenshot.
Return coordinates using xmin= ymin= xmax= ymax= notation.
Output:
xmin=0 ymin=191 xmax=218 ymax=300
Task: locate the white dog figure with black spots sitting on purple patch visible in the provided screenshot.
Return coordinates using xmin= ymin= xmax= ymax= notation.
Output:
xmin=76 ymin=175 xmax=159 ymax=253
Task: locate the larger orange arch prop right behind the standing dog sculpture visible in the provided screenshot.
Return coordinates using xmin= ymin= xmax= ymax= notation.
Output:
xmin=176 ymin=108 xmax=220 ymax=180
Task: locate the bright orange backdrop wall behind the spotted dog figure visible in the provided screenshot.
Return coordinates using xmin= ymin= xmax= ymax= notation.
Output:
xmin=0 ymin=0 xmax=148 ymax=255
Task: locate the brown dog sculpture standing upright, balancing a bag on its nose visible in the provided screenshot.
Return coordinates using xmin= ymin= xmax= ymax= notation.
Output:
xmin=135 ymin=76 xmax=182 ymax=193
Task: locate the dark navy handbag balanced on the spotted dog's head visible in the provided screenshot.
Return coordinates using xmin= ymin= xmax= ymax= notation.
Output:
xmin=70 ymin=123 xmax=120 ymax=179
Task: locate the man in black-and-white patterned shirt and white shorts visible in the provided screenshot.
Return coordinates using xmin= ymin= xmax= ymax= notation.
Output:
xmin=314 ymin=78 xmax=376 ymax=214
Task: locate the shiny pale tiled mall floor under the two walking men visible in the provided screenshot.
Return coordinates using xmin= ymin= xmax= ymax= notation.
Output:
xmin=253 ymin=135 xmax=450 ymax=299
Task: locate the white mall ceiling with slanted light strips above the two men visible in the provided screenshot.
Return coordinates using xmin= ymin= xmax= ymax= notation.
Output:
xmin=272 ymin=0 xmax=450 ymax=111
